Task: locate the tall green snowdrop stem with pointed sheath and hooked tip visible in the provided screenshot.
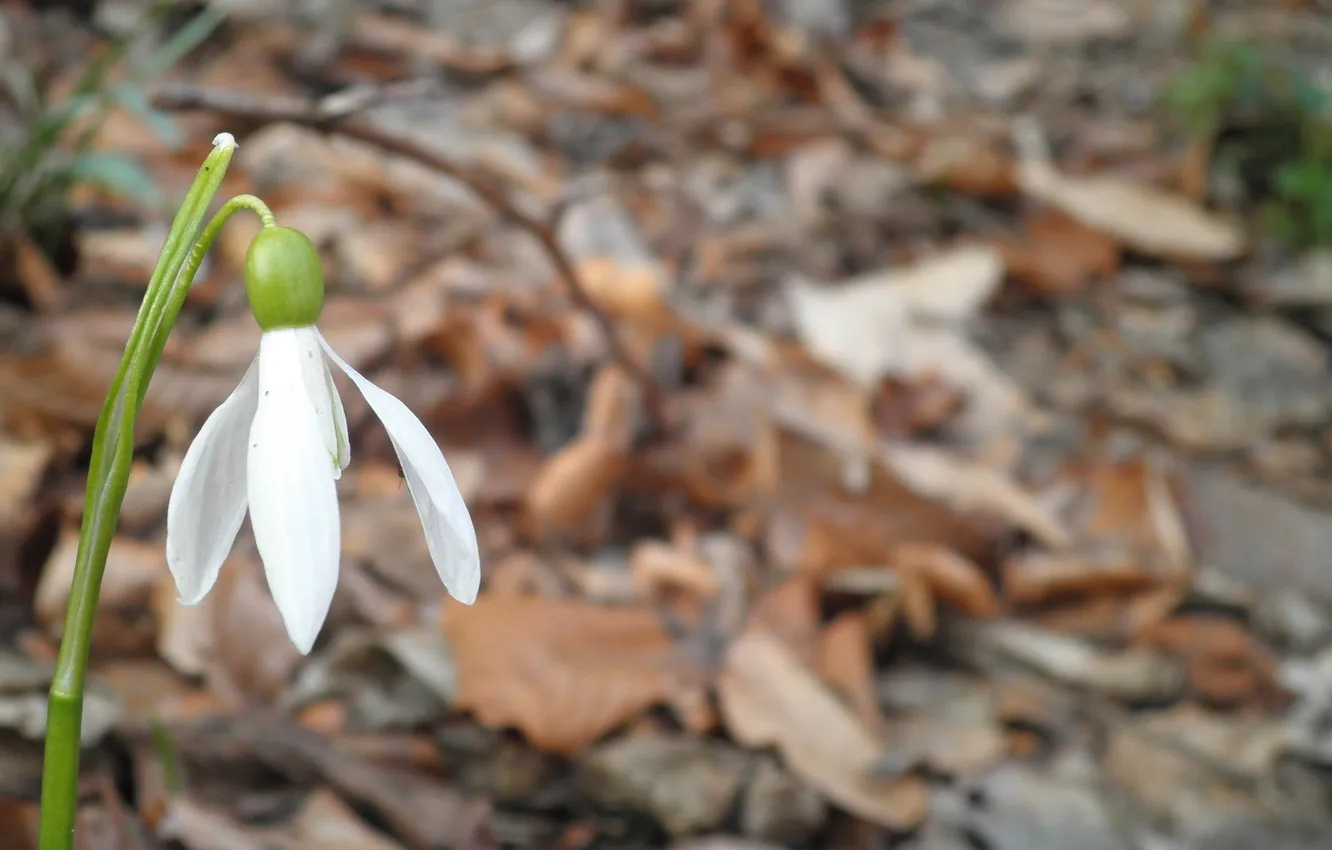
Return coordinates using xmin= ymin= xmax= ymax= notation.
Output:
xmin=39 ymin=140 xmax=273 ymax=850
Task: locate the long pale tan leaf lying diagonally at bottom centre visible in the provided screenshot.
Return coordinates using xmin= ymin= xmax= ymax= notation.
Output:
xmin=718 ymin=629 xmax=928 ymax=830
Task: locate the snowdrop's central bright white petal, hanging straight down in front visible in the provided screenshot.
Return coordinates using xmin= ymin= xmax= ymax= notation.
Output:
xmin=248 ymin=328 xmax=341 ymax=653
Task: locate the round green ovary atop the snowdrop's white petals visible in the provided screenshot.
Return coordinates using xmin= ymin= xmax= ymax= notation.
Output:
xmin=245 ymin=226 xmax=324 ymax=330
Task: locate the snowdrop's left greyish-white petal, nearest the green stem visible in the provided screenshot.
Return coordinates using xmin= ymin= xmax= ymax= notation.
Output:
xmin=167 ymin=358 xmax=258 ymax=605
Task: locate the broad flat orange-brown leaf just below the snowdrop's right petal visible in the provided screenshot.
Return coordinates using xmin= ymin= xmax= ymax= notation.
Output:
xmin=444 ymin=594 xmax=693 ymax=755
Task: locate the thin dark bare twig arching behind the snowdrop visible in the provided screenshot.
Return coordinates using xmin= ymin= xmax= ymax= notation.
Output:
xmin=153 ymin=84 xmax=665 ymax=430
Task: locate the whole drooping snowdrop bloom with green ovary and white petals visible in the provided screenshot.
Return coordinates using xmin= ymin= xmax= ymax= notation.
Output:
xmin=167 ymin=226 xmax=481 ymax=653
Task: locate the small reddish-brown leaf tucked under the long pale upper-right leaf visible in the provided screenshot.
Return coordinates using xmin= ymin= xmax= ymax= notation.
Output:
xmin=999 ymin=211 xmax=1119 ymax=294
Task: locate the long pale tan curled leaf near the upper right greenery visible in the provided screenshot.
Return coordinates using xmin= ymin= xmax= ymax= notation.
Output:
xmin=1018 ymin=157 xmax=1245 ymax=261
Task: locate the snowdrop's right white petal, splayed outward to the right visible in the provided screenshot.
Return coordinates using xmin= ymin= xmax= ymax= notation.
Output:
xmin=316 ymin=332 xmax=481 ymax=605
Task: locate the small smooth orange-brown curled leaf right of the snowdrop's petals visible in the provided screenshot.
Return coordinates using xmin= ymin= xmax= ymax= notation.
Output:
xmin=525 ymin=436 xmax=629 ymax=536
